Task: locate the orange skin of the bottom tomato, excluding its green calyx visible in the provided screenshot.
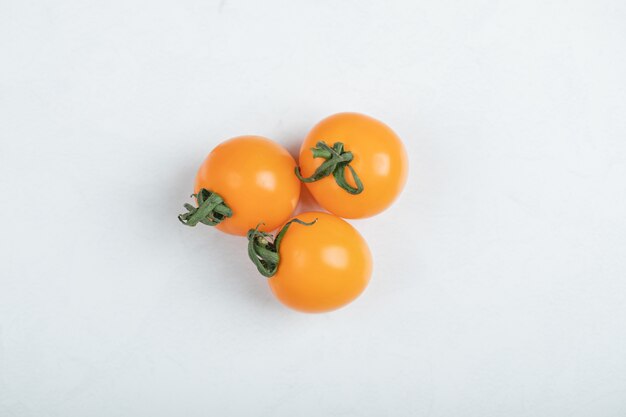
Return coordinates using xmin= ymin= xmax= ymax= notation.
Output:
xmin=268 ymin=212 xmax=372 ymax=313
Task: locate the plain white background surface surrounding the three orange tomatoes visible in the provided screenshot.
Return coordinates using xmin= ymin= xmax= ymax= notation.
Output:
xmin=0 ymin=0 xmax=626 ymax=417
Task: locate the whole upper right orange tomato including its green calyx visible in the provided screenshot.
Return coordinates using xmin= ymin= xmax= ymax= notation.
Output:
xmin=296 ymin=113 xmax=409 ymax=219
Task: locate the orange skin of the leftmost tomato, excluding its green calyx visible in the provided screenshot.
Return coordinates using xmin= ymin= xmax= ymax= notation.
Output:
xmin=194 ymin=136 xmax=300 ymax=236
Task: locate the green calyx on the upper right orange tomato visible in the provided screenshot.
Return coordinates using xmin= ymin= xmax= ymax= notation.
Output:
xmin=296 ymin=141 xmax=363 ymax=194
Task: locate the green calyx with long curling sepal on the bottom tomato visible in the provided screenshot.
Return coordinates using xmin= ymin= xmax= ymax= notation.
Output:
xmin=248 ymin=219 xmax=317 ymax=278
